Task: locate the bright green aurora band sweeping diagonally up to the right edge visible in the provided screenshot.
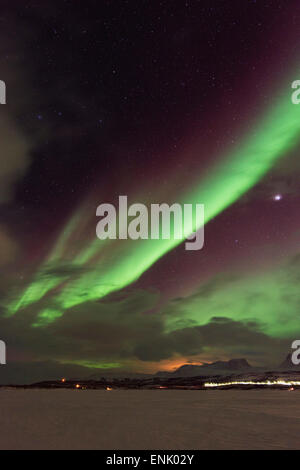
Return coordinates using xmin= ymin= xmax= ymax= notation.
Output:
xmin=7 ymin=77 xmax=300 ymax=326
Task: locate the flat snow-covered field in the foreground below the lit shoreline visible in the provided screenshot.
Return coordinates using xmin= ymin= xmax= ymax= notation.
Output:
xmin=0 ymin=389 xmax=300 ymax=450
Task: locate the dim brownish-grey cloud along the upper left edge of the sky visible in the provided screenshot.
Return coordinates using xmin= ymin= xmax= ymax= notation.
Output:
xmin=0 ymin=13 xmax=41 ymax=266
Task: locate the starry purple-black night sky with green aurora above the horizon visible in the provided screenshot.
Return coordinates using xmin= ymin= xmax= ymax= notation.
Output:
xmin=0 ymin=0 xmax=300 ymax=383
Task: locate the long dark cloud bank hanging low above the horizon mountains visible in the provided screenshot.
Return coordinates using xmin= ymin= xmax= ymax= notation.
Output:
xmin=0 ymin=278 xmax=291 ymax=382
